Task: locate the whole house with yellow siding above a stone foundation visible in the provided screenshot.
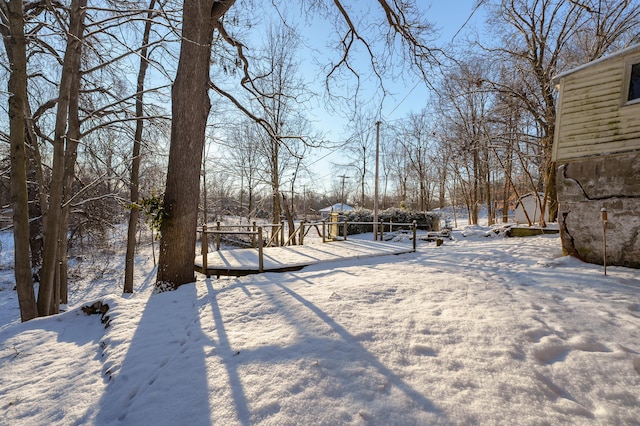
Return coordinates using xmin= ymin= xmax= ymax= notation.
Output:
xmin=553 ymin=44 xmax=640 ymax=268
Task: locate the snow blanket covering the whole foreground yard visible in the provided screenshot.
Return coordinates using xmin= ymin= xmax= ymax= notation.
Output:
xmin=0 ymin=227 xmax=640 ymax=425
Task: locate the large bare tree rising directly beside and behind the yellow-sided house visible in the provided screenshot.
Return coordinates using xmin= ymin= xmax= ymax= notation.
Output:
xmin=485 ymin=0 xmax=640 ymax=221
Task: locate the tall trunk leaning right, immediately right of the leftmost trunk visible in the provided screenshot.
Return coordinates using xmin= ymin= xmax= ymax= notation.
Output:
xmin=38 ymin=0 xmax=87 ymax=316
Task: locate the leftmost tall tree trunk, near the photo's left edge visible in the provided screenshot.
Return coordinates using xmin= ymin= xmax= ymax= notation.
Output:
xmin=3 ymin=0 xmax=38 ymax=321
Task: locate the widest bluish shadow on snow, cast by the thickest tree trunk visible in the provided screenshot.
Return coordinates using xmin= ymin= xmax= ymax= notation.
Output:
xmin=87 ymin=285 xmax=211 ymax=425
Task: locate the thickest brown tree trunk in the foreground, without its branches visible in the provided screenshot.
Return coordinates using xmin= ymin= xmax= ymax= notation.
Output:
xmin=157 ymin=0 xmax=234 ymax=287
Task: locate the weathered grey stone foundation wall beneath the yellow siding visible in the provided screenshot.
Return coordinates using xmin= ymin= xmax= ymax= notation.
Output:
xmin=557 ymin=152 xmax=640 ymax=268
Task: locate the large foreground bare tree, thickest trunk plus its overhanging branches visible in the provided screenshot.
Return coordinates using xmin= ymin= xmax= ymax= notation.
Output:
xmin=157 ymin=0 xmax=434 ymax=287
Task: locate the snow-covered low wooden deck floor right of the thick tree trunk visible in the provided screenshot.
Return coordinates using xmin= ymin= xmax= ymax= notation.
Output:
xmin=195 ymin=240 xmax=414 ymax=276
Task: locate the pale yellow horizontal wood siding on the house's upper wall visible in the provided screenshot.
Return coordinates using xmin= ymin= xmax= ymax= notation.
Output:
xmin=553 ymin=46 xmax=640 ymax=162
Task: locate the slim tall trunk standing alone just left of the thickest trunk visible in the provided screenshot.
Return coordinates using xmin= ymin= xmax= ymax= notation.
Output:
xmin=123 ymin=0 xmax=156 ymax=293
